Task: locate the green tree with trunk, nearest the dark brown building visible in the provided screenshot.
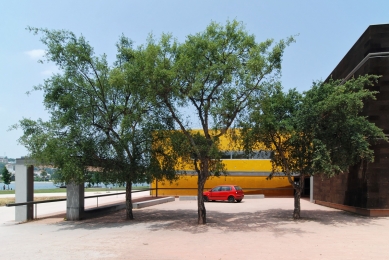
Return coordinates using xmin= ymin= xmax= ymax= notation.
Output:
xmin=242 ymin=76 xmax=386 ymax=219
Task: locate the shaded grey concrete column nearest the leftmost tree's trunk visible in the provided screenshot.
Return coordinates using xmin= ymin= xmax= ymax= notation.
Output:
xmin=66 ymin=183 xmax=84 ymax=220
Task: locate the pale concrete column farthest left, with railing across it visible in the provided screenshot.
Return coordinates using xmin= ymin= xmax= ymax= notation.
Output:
xmin=15 ymin=159 xmax=34 ymax=222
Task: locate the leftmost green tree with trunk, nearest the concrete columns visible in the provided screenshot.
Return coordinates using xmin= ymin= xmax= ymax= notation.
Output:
xmin=19 ymin=28 xmax=175 ymax=219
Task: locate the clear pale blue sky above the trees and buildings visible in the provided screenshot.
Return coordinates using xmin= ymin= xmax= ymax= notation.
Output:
xmin=0 ymin=0 xmax=389 ymax=158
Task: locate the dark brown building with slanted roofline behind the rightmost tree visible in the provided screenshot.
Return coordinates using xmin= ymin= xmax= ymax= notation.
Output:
xmin=313 ymin=24 xmax=389 ymax=216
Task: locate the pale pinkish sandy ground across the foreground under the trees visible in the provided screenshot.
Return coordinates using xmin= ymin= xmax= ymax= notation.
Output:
xmin=0 ymin=198 xmax=389 ymax=260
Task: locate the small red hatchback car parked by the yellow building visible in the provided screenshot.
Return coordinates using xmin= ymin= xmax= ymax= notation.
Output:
xmin=203 ymin=185 xmax=244 ymax=203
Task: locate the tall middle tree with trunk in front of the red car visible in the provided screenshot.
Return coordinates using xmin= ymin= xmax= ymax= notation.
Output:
xmin=145 ymin=21 xmax=293 ymax=224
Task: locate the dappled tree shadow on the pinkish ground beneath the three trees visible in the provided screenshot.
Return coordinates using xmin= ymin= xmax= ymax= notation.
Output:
xmin=51 ymin=206 xmax=375 ymax=236
